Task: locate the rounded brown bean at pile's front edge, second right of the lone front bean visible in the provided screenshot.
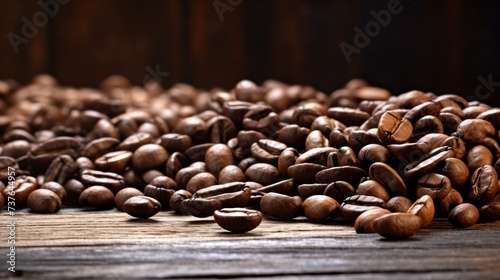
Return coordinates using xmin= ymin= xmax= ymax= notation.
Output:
xmin=302 ymin=195 xmax=340 ymax=221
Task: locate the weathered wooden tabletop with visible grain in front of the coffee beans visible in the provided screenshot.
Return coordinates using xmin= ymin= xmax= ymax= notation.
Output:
xmin=0 ymin=208 xmax=500 ymax=279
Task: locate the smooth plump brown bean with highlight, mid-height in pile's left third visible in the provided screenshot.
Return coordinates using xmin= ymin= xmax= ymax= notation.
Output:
xmin=132 ymin=144 xmax=170 ymax=171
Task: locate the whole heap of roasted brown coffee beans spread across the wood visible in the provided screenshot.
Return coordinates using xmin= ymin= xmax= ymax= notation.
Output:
xmin=0 ymin=75 xmax=500 ymax=239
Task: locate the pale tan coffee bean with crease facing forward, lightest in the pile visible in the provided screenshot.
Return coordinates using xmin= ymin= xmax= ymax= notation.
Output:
xmin=378 ymin=111 xmax=413 ymax=145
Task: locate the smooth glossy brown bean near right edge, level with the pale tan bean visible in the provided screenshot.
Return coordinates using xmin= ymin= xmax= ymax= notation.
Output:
xmin=457 ymin=119 xmax=495 ymax=144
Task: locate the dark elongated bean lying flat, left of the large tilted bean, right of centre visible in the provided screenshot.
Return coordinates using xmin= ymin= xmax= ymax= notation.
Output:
xmin=316 ymin=166 xmax=366 ymax=185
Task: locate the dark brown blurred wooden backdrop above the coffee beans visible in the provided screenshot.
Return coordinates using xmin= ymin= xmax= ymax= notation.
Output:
xmin=0 ymin=0 xmax=500 ymax=106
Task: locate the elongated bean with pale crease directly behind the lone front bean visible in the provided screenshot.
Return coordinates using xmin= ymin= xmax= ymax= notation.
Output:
xmin=193 ymin=182 xmax=252 ymax=208
